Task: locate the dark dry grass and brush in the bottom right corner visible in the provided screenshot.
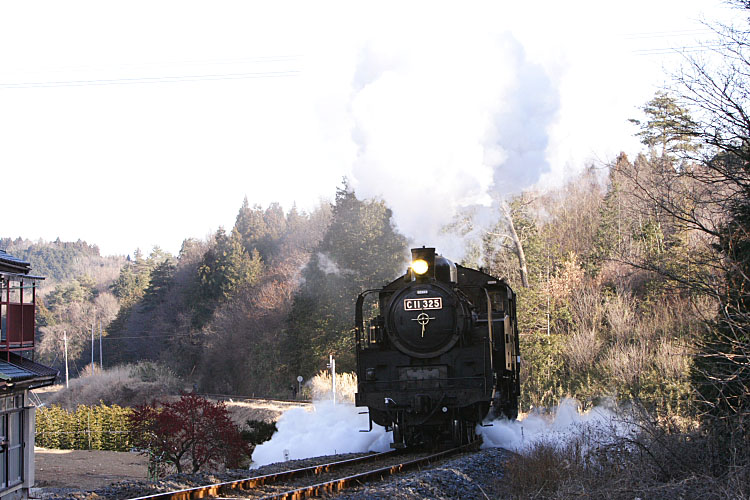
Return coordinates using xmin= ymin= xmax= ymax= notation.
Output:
xmin=501 ymin=408 xmax=750 ymax=500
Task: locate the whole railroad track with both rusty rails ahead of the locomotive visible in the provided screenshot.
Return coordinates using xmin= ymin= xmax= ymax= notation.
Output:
xmin=132 ymin=441 xmax=480 ymax=500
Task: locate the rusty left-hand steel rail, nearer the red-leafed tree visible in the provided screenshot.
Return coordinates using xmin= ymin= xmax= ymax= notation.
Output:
xmin=131 ymin=450 xmax=396 ymax=500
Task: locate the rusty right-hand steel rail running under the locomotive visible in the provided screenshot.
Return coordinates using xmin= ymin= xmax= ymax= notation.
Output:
xmin=261 ymin=440 xmax=481 ymax=500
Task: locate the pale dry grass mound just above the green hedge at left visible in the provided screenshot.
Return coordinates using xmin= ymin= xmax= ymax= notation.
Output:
xmin=45 ymin=362 xmax=182 ymax=410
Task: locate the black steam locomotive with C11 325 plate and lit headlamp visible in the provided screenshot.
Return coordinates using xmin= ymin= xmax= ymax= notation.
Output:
xmin=355 ymin=248 xmax=520 ymax=448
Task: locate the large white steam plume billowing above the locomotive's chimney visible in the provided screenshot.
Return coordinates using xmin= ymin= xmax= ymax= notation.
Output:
xmin=350 ymin=19 xmax=559 ymax=257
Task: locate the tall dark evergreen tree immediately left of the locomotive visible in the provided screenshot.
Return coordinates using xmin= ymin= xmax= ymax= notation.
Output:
xmin=288 ymin=184 xmax=408 ymax=376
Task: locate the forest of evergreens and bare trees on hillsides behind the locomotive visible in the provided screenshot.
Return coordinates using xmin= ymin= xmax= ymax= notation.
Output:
xmin=0 ymin=2 xmax=750 ymax=492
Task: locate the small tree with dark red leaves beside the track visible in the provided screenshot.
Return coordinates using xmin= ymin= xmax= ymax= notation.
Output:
xmin=129 ymin=394 xmax=249 ymax=473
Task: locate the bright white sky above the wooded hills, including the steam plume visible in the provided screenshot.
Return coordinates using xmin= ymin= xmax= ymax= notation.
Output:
xmin=0 ymin=0 xmax=740 ymax=255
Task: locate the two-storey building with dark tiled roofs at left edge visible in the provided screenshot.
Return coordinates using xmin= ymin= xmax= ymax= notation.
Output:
xmin=0 ymin=250 xmax=57 ymax=500
